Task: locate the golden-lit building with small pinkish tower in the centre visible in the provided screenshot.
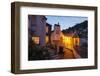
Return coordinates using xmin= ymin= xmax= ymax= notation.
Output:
xmin=51 ymin=24 xmax=80 ymax=51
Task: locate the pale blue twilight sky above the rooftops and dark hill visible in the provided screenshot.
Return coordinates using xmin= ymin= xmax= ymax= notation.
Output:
xmin=46 ymin=16 xmax=88 ymax=30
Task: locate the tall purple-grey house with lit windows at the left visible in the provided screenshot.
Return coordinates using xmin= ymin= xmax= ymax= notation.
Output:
xmin=28 ymin=15 xmax=51 ymax=46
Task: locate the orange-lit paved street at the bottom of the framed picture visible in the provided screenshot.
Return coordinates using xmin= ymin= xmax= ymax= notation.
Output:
xmin=49 ymin=48 xmax=81 ymax=59
